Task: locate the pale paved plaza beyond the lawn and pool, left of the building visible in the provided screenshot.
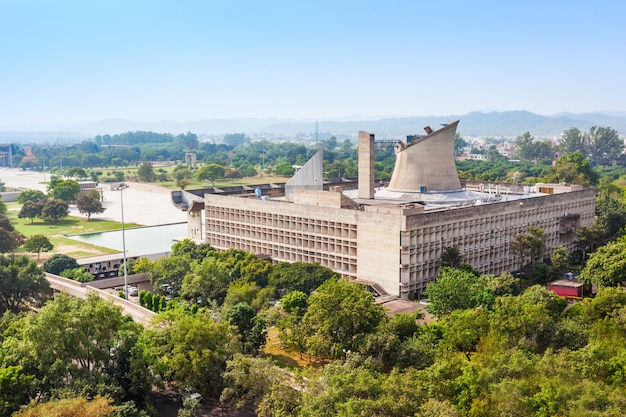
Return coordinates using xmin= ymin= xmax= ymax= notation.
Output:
xmin=0 ymin=168 xmax=187 ymax=226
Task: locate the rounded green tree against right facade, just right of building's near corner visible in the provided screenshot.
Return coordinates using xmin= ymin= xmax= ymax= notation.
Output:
xmin=426 ymin=268 xmax=495 ymax=317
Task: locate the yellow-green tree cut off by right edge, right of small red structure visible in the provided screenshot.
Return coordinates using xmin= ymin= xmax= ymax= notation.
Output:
xmin=580 ymin=238 xmax=626 ymax=287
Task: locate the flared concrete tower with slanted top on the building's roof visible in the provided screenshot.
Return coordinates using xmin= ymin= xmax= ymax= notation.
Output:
xmin=387 ymin=120 xmax=461 ymax=192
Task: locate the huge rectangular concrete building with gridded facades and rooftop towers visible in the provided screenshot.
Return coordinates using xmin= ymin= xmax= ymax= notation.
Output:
xmin=172 ymin=122 xmax=595 ymax=299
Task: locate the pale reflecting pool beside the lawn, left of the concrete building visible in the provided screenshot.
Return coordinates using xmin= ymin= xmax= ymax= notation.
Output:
xmin=67 ymin=223 xmax=187 ymax=255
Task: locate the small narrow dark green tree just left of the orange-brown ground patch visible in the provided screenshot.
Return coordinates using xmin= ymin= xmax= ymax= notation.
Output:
xmin=226 ymin=301 xmax=267 ymax=355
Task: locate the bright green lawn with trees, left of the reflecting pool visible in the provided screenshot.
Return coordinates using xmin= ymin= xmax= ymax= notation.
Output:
xmin=7 ymin=203 xmax=137 ymax=262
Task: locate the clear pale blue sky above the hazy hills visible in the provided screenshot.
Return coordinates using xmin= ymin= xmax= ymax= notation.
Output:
xmin=0 ymin=0 xmax=626 ymax=129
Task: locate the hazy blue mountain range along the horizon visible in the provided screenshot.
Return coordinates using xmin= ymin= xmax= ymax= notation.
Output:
xmin=0 ymin=110 xmax=626 ymax=142
